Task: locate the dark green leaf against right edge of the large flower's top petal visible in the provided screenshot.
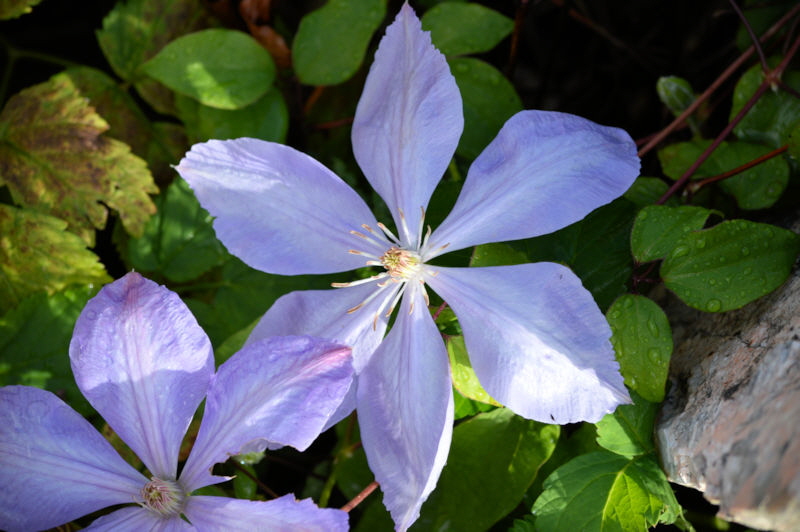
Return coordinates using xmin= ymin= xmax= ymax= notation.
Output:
xmin=447 ymin=57 xmax=522 ymax=159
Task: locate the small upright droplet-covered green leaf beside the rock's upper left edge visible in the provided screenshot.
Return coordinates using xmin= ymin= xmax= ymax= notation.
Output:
xmin=606 ymin=294 xmax=672 ymax=403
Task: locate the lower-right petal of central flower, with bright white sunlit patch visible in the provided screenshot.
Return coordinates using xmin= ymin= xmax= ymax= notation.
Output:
xmin=428 ymin=262 xmax=630 ymax=423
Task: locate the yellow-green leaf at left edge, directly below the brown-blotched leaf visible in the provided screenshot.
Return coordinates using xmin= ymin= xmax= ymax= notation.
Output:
xmin=0 ymin=204 xmax=111 ymax=310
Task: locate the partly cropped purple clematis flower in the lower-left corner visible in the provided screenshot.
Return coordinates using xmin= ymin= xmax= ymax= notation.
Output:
xmin=0 ymin=273 xmax=353 ymax=532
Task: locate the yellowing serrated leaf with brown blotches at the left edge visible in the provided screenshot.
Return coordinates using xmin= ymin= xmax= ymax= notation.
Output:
xmin=0 ymin=74 xmax=158 ymax=245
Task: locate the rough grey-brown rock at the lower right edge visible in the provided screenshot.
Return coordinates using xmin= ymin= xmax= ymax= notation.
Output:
xmin=656 ymin=219 xmax=800 ymax=531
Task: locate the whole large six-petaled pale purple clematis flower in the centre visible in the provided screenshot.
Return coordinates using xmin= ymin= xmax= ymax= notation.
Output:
xmin=177 ymin=4 xmax=639 ymax=530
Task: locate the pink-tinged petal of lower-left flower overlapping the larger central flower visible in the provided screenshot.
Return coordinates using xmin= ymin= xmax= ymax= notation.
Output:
xmin=181 ymin=336 xmax=353 ymax=492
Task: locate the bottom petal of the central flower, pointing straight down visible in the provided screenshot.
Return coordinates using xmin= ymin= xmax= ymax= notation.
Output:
xmin=357 ymin=283 xmax=453 ymax=530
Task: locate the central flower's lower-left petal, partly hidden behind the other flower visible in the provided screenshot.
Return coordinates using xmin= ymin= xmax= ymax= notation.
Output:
xmin=247 ymin=283 xmax=399 ymax=373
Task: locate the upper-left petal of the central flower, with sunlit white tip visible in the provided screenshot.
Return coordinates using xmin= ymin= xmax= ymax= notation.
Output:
xmin=176 ymin=138 xmax=385 ymax=275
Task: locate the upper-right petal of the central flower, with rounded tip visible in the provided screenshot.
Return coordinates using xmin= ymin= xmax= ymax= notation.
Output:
xmin=426 ymin=111 xmax=639 ymax=259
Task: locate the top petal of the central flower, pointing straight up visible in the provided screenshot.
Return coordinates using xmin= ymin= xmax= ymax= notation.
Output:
xmin=352 ymin=3 xmax=464 ymax=248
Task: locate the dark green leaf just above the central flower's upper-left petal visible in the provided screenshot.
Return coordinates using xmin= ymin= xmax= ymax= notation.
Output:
xmin=175 ymin=87 xmax=289 ymax=143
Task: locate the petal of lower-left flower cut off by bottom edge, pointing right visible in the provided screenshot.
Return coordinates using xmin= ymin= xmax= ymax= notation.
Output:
xmin=185 ymin=495 xmax=348 ymax=532
